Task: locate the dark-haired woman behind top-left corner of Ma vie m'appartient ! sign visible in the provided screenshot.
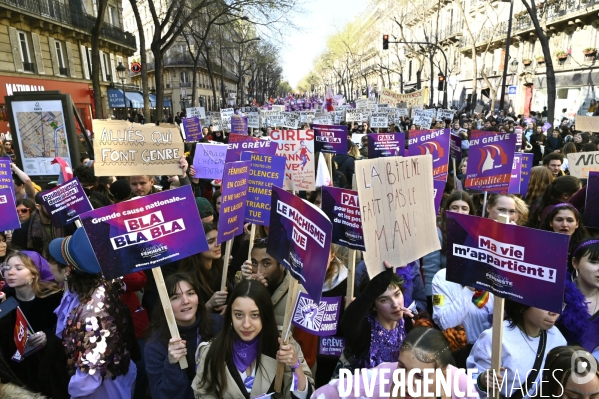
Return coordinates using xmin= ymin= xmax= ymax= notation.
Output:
xmin=422 ymin=191 xmax=474 ymax=314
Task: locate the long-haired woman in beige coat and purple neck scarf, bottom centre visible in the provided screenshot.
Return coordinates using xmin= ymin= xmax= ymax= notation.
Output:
xmin=192 ymin=280 xmax=313 ymax=399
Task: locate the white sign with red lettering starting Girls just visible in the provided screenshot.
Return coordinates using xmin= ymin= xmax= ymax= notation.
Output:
xmin=270 ymin=130 xmax=316 ymax=191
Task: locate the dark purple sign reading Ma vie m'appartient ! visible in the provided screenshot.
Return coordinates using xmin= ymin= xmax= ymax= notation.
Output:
xmin=446 ymin=212 xmax=570 ymax=313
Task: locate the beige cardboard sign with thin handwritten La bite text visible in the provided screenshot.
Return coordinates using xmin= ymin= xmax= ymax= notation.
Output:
xmin=356 ymin=154 xmax=441 ymax=278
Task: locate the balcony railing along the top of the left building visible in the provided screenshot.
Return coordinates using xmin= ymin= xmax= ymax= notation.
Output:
xmin=0 ymin=0 xmax=137 ymax=49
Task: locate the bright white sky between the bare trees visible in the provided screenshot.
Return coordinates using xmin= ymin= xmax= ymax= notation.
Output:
xmin=281 ymin=0 xmax=367 ymax=89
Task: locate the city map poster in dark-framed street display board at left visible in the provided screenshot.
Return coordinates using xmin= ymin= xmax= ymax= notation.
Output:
xmin=11 ymin=99 xmax=74 ymax=176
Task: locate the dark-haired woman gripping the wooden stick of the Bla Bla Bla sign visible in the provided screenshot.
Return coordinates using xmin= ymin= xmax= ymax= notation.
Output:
xmin=144 ymin=273 xmax=222 ymax=399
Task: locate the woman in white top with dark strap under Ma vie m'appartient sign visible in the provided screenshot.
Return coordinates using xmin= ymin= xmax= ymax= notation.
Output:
xmin=467 ymin=299 xmax=566 ymax=399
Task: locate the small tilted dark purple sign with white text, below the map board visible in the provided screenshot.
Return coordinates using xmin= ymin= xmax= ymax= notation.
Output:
xmin=42 ymin=177 xmax=93 ymax=227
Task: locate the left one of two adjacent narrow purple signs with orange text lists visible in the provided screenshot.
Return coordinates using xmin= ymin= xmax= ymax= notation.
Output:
xmin=216 ymin=161 xmax=250 ymax=244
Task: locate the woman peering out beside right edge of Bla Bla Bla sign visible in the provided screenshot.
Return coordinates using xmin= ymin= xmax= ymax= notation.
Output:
xmin=179 ymin=223 xmax=231 ymax=313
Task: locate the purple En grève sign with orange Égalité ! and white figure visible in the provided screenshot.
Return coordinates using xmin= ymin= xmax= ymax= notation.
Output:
xmin=466 ymin=130 xmax=516 ymax=194
